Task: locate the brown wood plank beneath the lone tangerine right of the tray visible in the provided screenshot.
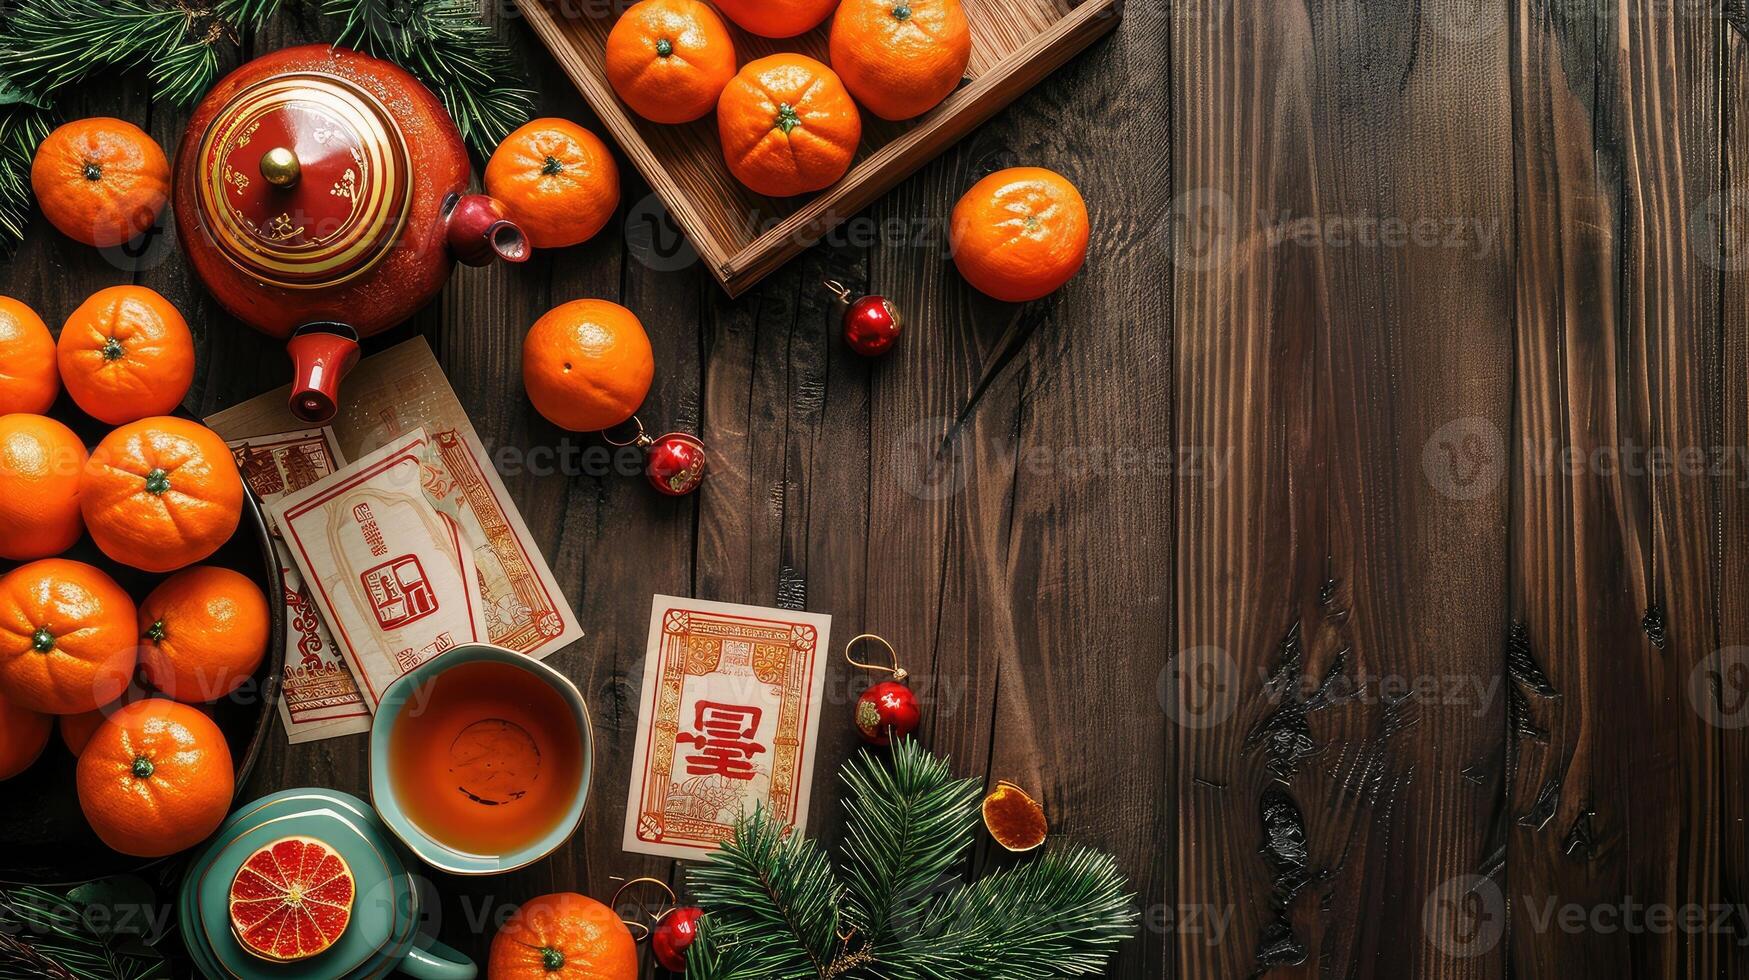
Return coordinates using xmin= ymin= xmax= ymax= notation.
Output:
xmin=972 ymin=5 xmax=1175 ymax=978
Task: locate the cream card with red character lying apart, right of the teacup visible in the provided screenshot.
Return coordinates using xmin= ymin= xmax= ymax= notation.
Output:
xmin=623 ymin=595 xmax=833 ymax=858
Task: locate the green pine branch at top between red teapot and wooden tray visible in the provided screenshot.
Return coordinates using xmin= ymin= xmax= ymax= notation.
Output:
xmin=322 ymin=0 xmax=535 ymax=156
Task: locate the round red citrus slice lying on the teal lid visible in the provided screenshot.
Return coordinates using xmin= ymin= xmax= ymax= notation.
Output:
xmin=231 ymin=837 xmax=357 ymax=963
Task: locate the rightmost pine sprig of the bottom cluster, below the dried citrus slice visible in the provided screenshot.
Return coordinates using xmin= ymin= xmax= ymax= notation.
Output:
xmin=880 ymin=847 xmax=1137 ymax=980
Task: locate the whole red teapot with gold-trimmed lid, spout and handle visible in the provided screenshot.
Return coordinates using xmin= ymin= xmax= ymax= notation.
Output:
xmin=175 ymin=44 xmax=530 ymax=424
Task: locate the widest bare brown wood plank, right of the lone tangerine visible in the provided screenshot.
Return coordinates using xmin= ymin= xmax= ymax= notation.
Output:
xmin=1172 ymin=4 xmax=1511 ymax=977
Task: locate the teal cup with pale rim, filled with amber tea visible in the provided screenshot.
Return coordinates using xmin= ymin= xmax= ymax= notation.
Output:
xmin=371 ymin=644 xmax=595 ymax=875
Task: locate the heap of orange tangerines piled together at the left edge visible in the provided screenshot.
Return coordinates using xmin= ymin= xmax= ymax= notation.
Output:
xmin=0 ymin=285 xmax=269 ymax=858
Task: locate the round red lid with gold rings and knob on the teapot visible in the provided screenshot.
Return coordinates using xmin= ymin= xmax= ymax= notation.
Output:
xmin=196 ymin=72 xmax=413 ymax=289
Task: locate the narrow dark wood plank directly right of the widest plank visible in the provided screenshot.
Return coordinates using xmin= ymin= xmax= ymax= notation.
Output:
xmin=1499 ymin=4 xmax=1651 ymax=977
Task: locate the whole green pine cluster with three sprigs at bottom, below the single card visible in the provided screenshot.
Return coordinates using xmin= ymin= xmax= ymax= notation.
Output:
xmin=686 ymin=740 xmax=1139 ymax=980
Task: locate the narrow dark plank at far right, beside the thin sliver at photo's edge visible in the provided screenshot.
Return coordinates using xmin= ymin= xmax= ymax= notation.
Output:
xmin=1611 ymin=9 xmax=1725 ymax=977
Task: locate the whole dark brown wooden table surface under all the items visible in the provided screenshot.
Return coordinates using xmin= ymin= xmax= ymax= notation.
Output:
xmin=10 ymin=0 xmax=1749 ymax=980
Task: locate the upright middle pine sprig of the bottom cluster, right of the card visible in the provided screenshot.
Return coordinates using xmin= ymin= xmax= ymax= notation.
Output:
xmin=841 ymin=739 xmax=979 ymax=947
